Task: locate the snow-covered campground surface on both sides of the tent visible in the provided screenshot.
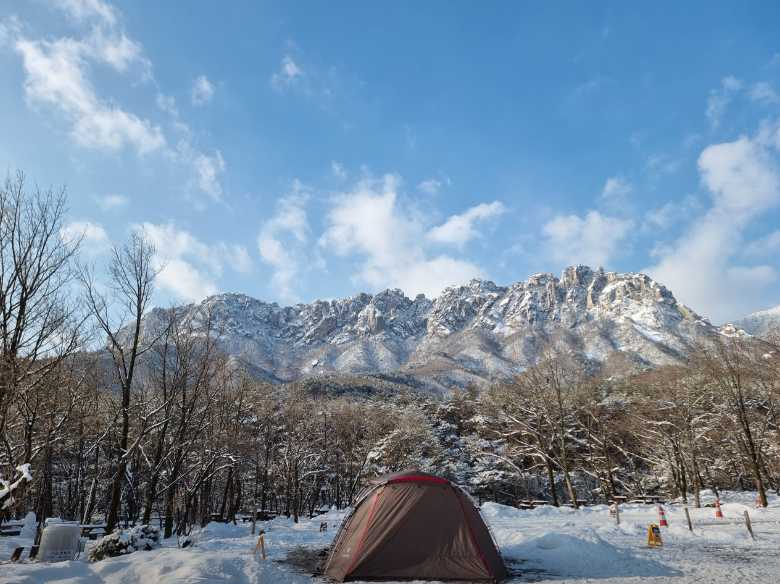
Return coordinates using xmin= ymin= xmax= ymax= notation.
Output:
xmin=0 ymin=493 xmax=780 ymax=584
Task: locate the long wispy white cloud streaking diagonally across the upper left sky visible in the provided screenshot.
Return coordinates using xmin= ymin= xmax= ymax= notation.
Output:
xmin=12 ymin=0 xmax=225 ymax=201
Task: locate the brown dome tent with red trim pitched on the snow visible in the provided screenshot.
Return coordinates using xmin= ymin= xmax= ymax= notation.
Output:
xmin=325 ymin=471 xmax=506 ymax=582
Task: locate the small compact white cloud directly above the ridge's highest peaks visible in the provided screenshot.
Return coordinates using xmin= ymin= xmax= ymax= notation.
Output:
xmin=542 ymin=211 xmax=633 ymax=267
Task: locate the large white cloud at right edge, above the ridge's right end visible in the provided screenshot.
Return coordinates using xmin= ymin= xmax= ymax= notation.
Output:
xmin=647 ymin=130 xmax=780 ymax=322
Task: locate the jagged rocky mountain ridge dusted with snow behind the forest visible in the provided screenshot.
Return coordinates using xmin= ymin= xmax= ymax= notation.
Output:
xmin=139 ymin=266 xmax=718 ymax=390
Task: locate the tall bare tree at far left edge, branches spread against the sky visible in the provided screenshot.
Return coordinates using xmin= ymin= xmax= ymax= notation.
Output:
xmin=0 ymin=172 xmax=83 ymax=460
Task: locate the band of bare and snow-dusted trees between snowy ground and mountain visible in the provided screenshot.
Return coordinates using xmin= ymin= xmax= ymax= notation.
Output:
xmin=0 ymin=175 xmax=780 ymax=537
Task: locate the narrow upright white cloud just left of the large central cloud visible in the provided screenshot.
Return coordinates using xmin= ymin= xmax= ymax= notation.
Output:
xmin=257 ymin=181 xmax=309 ymax=302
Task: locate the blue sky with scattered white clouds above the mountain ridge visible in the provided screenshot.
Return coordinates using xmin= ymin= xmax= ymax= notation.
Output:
xmin=0 ymin=0 xmax=780 ymax=322
